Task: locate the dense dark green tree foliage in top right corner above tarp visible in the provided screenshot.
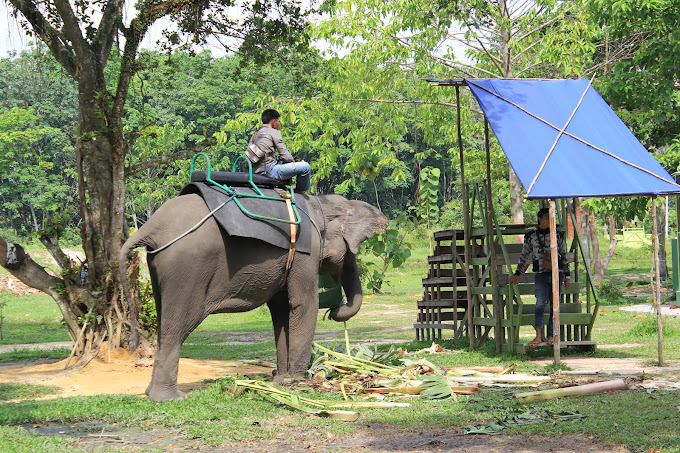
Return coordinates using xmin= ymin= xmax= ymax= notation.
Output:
xmin=587 ymin=0 xmax=680 ymax=152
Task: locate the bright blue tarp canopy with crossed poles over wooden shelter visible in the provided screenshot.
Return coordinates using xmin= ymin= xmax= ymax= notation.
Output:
xmin=429 ymin=79 xmax=680 ymax=198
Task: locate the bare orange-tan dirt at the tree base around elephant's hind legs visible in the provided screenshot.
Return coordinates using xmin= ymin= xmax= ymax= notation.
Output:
xmin=0 ymin=342 xmax=272 ymax=399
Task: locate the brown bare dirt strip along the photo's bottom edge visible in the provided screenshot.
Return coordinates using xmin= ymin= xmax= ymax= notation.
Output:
xmin=25 ymin=423 xmax=630 ymax=453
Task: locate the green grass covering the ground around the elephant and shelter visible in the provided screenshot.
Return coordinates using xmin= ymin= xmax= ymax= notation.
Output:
xmin=0 ymin=238 xmax=680 ymax=453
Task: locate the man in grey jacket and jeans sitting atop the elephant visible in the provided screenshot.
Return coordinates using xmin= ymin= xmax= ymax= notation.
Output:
xmin=250 ymin=109 xmax=312 ymax=192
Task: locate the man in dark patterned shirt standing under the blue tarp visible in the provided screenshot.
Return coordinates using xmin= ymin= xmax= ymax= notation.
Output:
xmin=508 ymin=208 xmax=571 ymax=347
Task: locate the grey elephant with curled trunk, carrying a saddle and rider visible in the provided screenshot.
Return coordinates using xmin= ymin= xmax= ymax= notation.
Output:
xmin=119 ymin=194 xmax=388 ymax=401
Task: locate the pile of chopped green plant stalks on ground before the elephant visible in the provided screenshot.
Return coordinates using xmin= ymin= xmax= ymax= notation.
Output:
xmin=234 ymin=341 xmax=551 ymax=421
